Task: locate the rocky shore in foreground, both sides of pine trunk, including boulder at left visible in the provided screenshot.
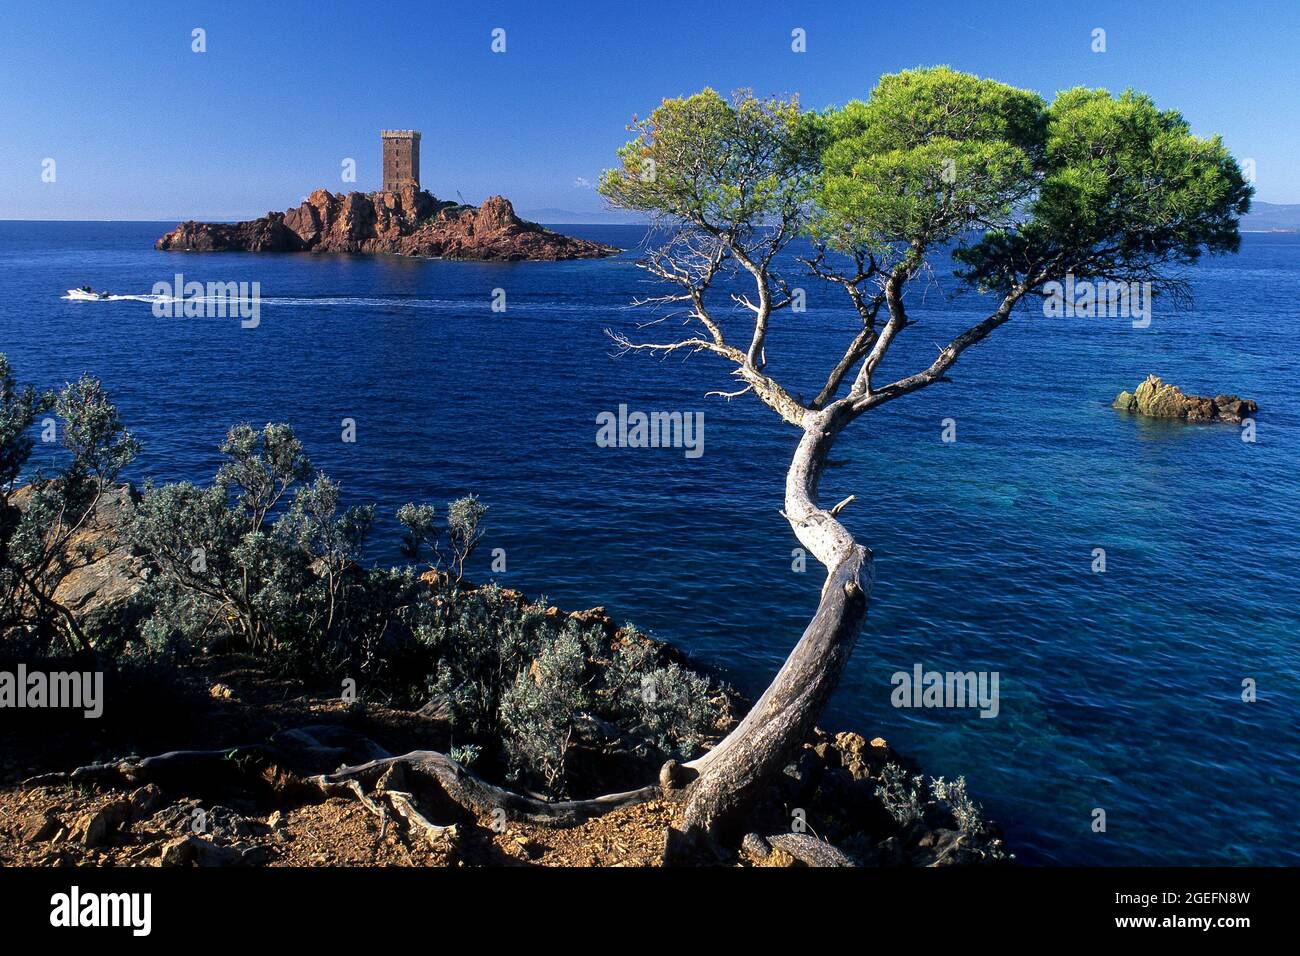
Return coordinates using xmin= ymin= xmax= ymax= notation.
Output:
xmin=0 ymin=485 xmax=1011 ymax=866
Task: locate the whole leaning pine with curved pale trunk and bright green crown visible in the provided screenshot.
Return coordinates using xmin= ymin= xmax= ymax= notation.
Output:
xmin=601 ymin=68 xmax=1252 ymax=847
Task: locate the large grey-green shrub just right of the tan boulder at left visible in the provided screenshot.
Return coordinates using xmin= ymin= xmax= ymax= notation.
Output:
xmin=130 ymin=425 xmax=434 ymax=675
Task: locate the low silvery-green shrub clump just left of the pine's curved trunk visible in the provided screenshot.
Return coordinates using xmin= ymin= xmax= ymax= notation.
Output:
xmin=413 ymin=584 xmax=724 ymax=792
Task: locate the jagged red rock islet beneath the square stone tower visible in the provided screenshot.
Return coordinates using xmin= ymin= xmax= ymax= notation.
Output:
xmin=155 ymin=186 xmax=618 ymax=260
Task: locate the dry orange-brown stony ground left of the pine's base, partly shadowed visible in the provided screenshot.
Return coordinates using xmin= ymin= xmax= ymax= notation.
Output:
xmin=0 ymin=657 xmax=696 ymax=866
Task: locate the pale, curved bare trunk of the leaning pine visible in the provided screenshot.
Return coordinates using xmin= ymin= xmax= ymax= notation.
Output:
xmin=668 ymin=406 xmax=874 ymax=855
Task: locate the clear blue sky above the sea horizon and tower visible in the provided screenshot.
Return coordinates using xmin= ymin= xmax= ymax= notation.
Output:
xmin=0 ymin=0 xmax=1300 ymax=220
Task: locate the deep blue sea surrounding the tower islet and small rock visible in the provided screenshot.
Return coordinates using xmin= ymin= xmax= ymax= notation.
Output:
xmin=0 ymin=222 xmax=1300 ymax=865
